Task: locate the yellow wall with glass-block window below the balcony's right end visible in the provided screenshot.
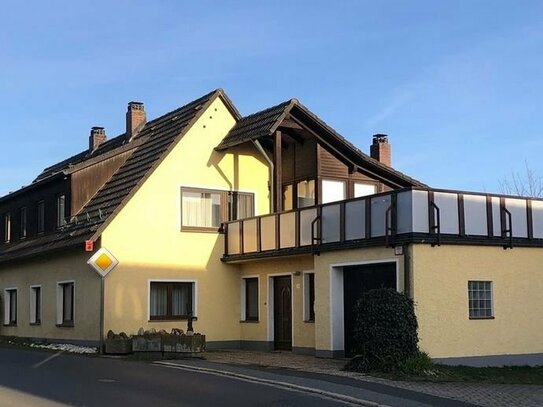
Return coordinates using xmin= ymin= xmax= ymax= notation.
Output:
xmin=412 ymin=245 xmax=543 ymax=357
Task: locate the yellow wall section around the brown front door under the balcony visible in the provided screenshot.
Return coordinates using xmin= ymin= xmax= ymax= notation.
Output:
xmin=240 ymin=255 xmax=315 ymax=348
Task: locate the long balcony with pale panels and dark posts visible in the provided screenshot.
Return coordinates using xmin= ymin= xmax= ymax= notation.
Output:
xmin=223 ymin=188 xmax=543 ymax=262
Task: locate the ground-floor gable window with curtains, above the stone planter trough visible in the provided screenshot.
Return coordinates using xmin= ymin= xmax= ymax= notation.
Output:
xmin=149 ymin=282 xmax=195 ymax=320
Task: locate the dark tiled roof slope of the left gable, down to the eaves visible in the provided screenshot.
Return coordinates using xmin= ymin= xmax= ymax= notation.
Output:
xmin=0 ymin=90 xmax=222 ymax=263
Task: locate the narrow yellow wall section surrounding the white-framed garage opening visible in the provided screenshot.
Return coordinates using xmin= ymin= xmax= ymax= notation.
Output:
xmin=315 ymin=247 xmax=404 ymax=350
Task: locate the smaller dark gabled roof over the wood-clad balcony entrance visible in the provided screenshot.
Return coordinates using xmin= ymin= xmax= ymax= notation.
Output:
xmin=216 ymin=99 xmax=427 ymax=187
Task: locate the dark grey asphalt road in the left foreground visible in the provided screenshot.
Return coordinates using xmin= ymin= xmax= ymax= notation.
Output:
xmin=0 ymin=348 xmax=352 ymax=407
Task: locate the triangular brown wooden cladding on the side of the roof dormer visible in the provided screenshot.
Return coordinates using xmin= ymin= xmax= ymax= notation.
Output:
xmin=71 ymin=151 xmax=132 ymax=215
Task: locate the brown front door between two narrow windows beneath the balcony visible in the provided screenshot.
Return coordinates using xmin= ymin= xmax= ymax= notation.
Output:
xmin=273 ymin=276 xmax=292 ymax=350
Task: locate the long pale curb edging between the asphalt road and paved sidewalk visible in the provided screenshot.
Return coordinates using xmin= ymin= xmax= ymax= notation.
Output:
xmin=153 ymin=361 xmax=390 ymax=407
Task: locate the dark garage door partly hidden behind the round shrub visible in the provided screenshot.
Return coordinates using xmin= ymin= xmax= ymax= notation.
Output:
xmin=343 ymin=263 xmax=396 ymax=357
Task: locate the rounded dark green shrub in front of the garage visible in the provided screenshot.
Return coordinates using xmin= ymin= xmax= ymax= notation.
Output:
xmin=346 ymin=288 xmax=419 ymax=372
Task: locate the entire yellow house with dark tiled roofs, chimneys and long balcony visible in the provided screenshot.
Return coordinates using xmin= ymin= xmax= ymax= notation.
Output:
xmin=0 ymin=90 xmax=543 ymax=364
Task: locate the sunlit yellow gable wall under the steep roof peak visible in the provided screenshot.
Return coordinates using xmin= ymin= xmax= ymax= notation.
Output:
xmin=102 ymin=99 xmax=269 ymax=341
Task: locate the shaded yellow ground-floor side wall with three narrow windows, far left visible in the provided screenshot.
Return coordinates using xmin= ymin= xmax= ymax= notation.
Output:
xmin=0 ymin=252 xmax=100 ymax=341
